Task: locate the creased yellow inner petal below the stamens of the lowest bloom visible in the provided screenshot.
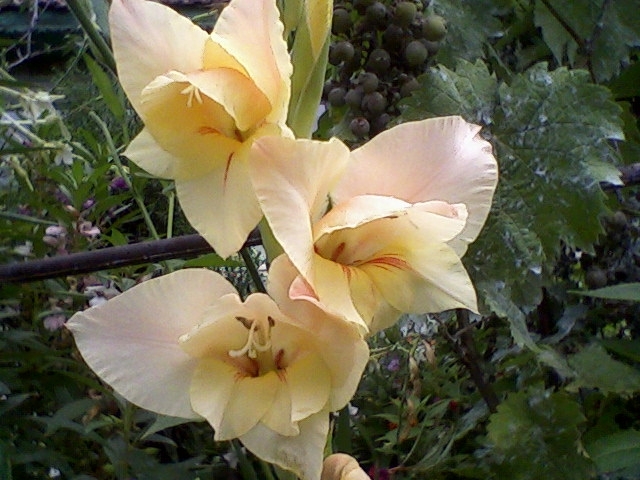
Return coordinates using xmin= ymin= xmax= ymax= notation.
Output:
xmin=191 ymin=358 xmax=280 ymax=440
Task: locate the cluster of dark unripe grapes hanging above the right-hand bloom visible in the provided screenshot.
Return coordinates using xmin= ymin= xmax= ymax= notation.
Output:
xmin=323 ymin=0 xmax=447 ymax=144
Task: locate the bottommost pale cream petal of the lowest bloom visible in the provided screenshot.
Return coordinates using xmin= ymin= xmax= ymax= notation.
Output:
xmin=240 ymin=411 xmax=329 ymax=480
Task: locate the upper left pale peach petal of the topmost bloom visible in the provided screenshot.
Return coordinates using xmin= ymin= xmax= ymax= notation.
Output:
xmin=109 ymin=0 xmax=208 ymax=112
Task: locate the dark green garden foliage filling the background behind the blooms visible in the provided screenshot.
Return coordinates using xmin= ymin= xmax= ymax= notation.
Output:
xmin=0 ymin=0 xmax=640 ymax=480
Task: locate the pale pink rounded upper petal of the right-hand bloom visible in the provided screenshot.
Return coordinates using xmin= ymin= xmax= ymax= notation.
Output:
xmin=333 ymin=117 xmax=498 ymax=254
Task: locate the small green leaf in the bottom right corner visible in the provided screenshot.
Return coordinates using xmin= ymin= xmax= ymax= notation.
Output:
xmin=585 ymin=430 xmax=640 ymax=474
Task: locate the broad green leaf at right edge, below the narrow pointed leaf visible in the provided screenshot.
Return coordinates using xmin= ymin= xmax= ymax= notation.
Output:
xmin=567 ymin=343 xmax=640 ymax=394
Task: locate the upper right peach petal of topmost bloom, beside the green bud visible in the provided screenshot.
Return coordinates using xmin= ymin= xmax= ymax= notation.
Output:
xmin=211 ymin=0 xmax=292 ymax=123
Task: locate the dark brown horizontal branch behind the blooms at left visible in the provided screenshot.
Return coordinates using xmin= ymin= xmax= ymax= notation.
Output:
xmin=0 ymin=231 xmax=261 ymax=284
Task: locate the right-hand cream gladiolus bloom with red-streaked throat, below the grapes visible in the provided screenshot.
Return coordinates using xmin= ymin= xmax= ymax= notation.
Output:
xmin=250 ymin=117 xmax=498 ymax=332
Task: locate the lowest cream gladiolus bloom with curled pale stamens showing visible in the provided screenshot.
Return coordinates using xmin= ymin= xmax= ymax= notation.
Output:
xmin=67 ymin=268 xmax=369 ymax=480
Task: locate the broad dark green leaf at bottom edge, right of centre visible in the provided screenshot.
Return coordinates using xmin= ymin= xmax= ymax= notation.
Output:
xmin=487 ymin=390 xmax=593 ymax=480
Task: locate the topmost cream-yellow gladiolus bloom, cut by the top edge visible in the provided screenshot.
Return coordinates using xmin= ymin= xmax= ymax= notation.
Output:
xmin=109 ymin=0 xmax=292 ymax=257
